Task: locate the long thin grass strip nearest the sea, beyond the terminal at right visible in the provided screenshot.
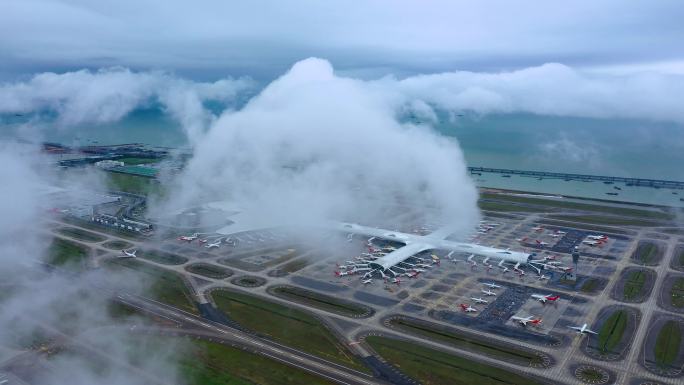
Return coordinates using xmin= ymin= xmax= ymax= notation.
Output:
xmin=480 ymin=193 xmax=674 ymax=220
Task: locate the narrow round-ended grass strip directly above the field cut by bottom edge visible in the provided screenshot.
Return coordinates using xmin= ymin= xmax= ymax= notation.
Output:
xmin=390 ymin=318 xmax=543 ymax=366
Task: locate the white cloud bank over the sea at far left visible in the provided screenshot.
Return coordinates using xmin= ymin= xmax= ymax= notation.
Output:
xmin=0 ymin=68 xmax=253 ymax=141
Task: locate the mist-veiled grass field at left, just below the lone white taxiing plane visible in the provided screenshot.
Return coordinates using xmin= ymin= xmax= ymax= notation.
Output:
xmin=103 ymin=258 xmax=199 ymax=314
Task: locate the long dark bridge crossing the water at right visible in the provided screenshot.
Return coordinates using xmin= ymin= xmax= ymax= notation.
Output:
xmin=468 ymin=167 xmax=684 ymax=189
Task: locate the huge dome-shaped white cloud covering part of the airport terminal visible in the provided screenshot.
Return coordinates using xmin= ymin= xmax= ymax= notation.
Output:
xmin=158 ymin=59 xmax=478 ymax=232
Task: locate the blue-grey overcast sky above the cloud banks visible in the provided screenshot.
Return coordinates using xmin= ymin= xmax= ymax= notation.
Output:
xmin=0 ymin=0 xmax=684 ymax=80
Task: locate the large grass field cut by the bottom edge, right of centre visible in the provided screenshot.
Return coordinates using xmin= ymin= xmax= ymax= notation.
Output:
xmin=366 ymin=336 xmax=539 ymax=385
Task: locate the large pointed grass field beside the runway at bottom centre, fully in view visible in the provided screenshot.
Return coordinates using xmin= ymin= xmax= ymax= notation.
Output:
xmin=211 ymin=290 xmax=368 ymax=372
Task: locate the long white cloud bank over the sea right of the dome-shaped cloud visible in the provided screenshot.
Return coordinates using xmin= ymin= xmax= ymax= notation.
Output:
xmin=388 ymin=63 xmax=684 ymax=124
